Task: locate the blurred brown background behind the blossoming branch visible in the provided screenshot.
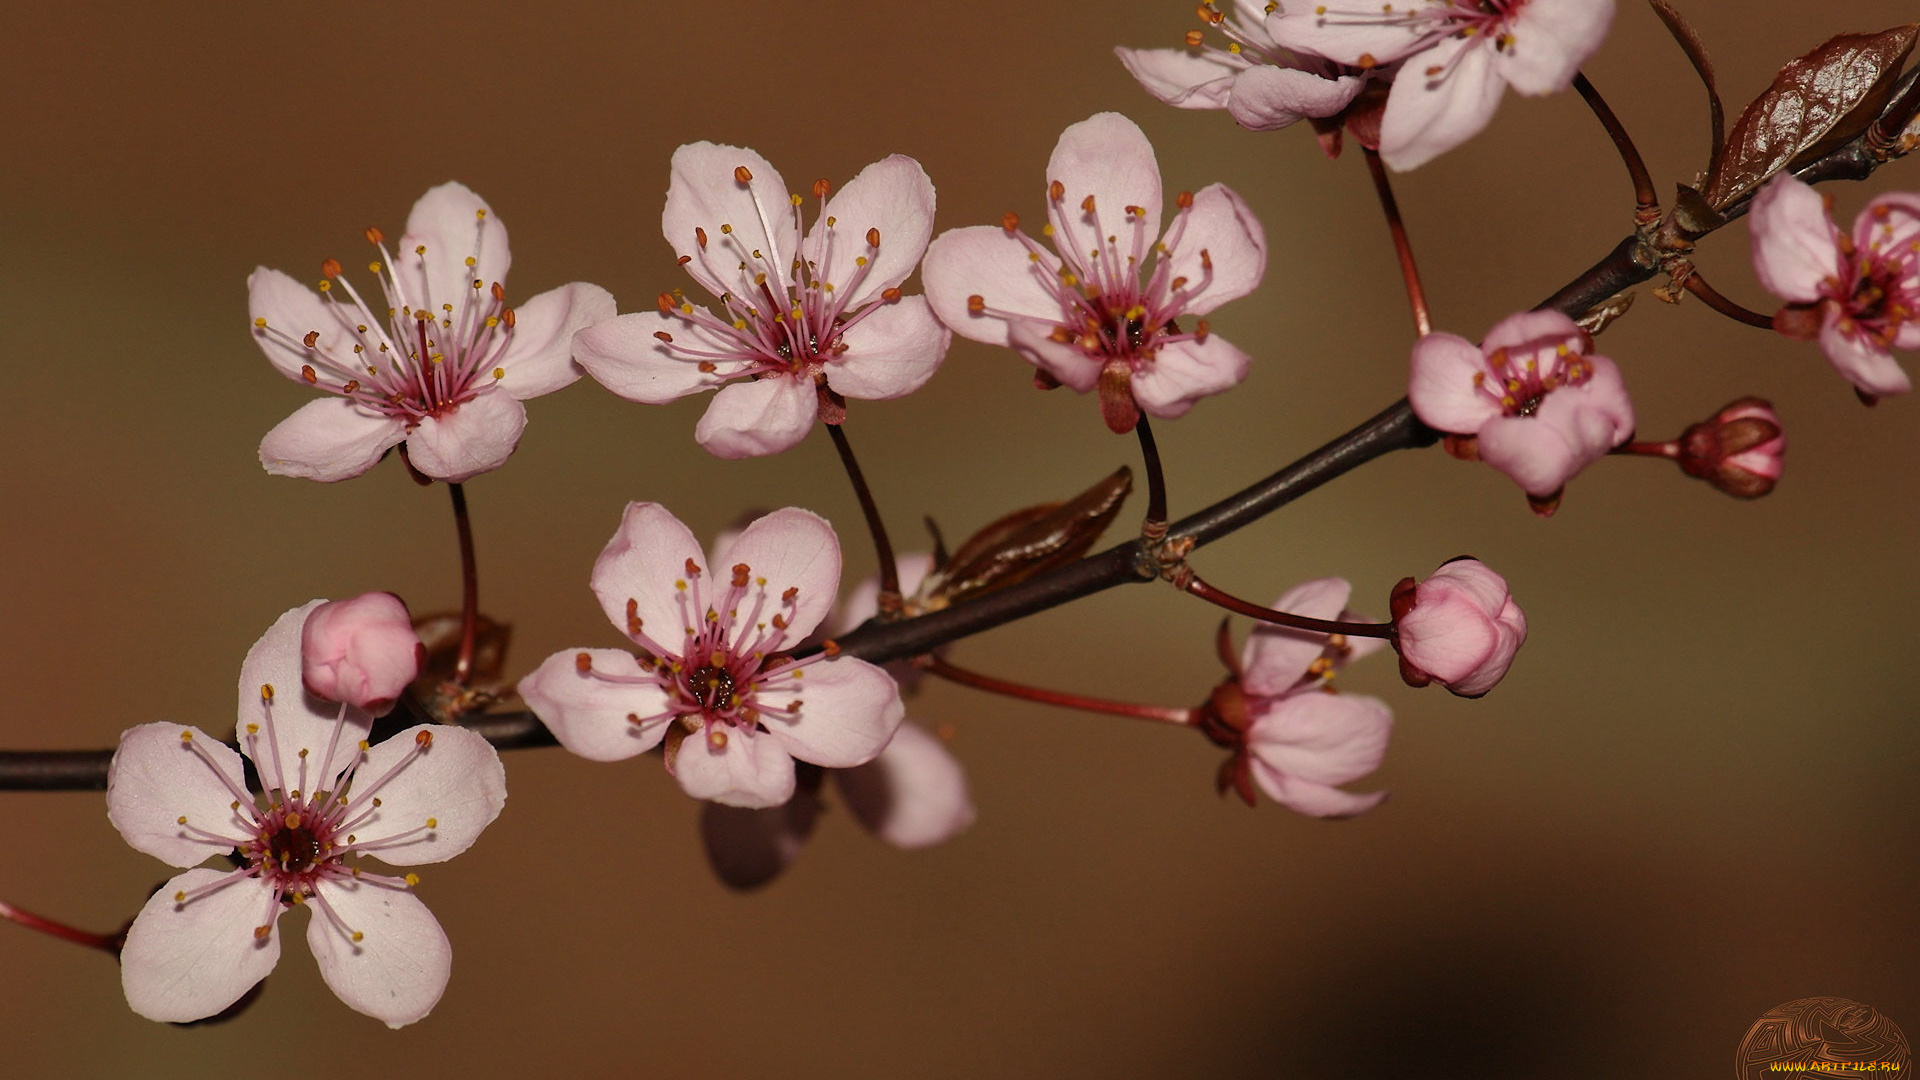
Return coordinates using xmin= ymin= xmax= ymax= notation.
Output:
xmin=0 ymin=0 xmax=1920 ymax=1080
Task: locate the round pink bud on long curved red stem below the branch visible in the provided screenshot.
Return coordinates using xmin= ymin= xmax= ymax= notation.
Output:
xmin=1392 ymin=557 xmax=1526 ymax=698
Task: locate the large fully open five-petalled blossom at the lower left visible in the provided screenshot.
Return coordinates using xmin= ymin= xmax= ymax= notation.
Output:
xmin=108 ymin=600 xmax=507 ymax=1028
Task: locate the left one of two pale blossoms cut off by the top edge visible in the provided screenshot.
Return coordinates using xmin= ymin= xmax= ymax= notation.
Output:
xmin=1114 ymin=0 xmax=1367 ymax=141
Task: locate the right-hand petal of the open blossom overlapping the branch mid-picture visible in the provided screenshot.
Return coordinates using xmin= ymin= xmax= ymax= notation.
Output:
xmin=755 ymin=655 xmax=906 ymax=769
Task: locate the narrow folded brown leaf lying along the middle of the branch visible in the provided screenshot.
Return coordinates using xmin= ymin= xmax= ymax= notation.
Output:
xmin=920 ymin=465 xmax=1133 ymax=611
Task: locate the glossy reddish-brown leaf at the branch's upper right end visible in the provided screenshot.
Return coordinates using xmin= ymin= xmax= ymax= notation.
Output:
xmin=1701 ymin=25 xmax=1920 ymax=209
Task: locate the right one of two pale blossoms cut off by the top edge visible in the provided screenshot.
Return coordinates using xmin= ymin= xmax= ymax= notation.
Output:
xmin=1267 ymin=0 xmax=1613 ymax=169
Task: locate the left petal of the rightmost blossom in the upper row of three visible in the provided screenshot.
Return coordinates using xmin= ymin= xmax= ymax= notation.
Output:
xmin=920 ymin=225 xmax=1060 ymax=346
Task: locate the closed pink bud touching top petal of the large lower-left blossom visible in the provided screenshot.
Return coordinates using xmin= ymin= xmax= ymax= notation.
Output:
xmin=300 ymin=592 xmax=426 ymax=713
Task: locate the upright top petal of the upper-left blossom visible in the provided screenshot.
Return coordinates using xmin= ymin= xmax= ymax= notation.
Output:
xmin=394 ymin=181 xmax=513 ymax=320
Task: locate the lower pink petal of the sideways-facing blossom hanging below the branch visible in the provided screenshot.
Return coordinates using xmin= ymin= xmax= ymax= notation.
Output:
xmin=1246 ymin=690 xmax=1394 ymax=817
